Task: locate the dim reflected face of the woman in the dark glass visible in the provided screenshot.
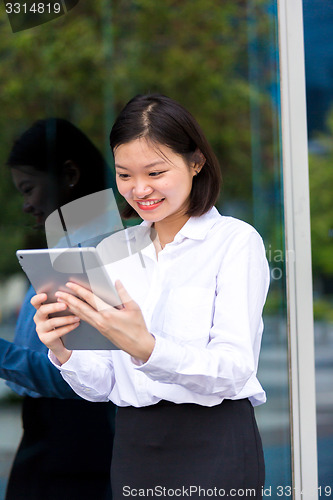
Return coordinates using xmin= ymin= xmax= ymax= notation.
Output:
xmin=11 ymin=166 xmax=63 ymax=227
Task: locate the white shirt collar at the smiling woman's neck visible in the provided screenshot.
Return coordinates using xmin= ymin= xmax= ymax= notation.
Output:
xmin=140 ymin=207 xmax=221 ymax=242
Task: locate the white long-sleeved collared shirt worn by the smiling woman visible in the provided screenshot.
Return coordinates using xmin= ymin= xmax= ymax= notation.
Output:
xmin=50 ymin=208 xmax=269 ymax=407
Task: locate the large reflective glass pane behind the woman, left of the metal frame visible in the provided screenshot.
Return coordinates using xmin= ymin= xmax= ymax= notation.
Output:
xmin=0 ymin=0 xmax=291 ymax=497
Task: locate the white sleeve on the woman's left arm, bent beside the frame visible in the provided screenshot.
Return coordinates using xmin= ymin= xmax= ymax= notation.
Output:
xmin=137 ymin=231 xmax=269 ymax=398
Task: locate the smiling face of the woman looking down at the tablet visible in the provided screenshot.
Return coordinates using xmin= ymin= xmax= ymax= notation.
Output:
xmin=114 ymin=138 xmax=195 ymax=222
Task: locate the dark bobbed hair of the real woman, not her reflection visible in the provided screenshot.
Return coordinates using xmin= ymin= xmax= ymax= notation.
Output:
xmin=110 ymin=94 xmax=221 ymax=218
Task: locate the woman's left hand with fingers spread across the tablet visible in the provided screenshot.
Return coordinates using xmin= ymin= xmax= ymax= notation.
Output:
xmin=56 ymin=280 xmax=155 ymax=362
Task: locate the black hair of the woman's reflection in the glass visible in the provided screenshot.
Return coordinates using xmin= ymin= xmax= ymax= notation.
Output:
xmin=6 ymin=118 xmax=113 ymax=199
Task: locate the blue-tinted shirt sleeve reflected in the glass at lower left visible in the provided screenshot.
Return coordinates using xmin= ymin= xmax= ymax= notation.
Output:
xmin=0 ymin=288 xmax=78 ymax=399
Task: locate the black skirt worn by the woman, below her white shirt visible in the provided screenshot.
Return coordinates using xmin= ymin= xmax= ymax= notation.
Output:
xmin=111 ymin=399 xmax=265 ymax=500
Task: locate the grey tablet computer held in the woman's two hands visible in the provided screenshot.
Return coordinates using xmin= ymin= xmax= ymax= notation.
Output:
xmin=16 ymin=247 xmax=121 ymax=350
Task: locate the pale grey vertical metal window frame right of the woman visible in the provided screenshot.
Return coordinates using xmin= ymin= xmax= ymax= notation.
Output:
xmin=278 ymin=0 xmax=318 ymax=500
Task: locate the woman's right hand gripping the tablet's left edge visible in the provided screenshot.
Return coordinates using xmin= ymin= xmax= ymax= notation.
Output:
xmin=31 ymin=293 xmax=80 ymax=364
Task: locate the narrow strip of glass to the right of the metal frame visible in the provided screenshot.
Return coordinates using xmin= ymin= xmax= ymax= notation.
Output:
xmin=303 ymin=0 xmax=333 ymax=496
